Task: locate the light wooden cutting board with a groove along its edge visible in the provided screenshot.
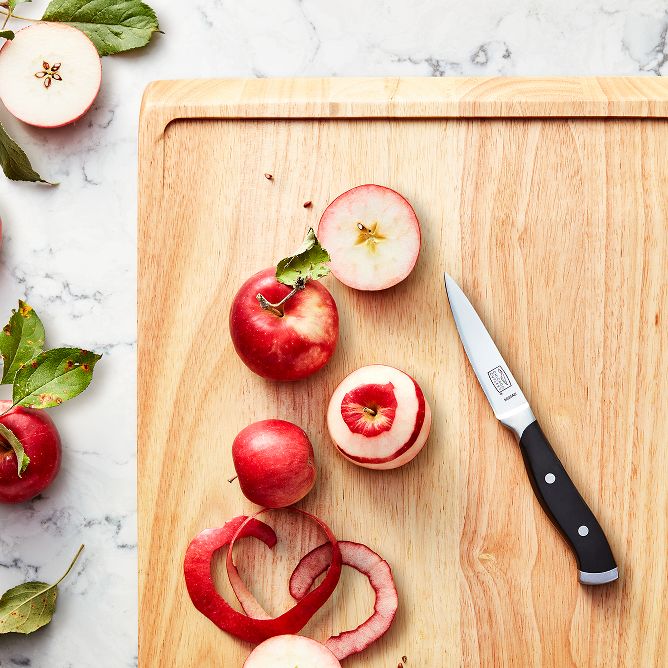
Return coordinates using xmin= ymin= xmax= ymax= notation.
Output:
xmin=137 ymin=78 xmax=668 ymax=668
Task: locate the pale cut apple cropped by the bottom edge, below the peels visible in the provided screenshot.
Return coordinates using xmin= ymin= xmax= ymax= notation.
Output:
xmin=243 ymin=635 xmax=341 ymax=668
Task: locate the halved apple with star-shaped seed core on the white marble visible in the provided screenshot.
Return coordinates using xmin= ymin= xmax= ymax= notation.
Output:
xmin=0 ymin=23 xmax=102 ymax=128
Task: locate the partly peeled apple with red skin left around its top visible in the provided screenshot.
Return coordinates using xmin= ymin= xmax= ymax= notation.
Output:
xmin=327 ymin=364 xmax=431 ymax=469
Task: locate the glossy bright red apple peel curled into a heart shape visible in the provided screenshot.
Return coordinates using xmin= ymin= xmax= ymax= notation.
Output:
xmin=184 ymin=508 xmax=341 ymax=643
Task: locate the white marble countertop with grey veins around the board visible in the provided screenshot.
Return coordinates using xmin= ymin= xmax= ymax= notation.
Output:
xmin=0 ymin=0 xmax=668 ymax=668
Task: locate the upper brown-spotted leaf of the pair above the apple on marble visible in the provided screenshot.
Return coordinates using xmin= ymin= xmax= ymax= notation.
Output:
xmin=0 ymin=299 xmax=44 ymax=385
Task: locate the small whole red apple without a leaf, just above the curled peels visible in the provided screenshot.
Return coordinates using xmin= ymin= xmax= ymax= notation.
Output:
xmin=232 ymin=420 xmax=316 ymax=508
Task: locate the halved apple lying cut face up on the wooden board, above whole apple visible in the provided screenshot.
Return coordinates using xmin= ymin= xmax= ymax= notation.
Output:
xmin=318 ymin=184 xmax=421 ymax=290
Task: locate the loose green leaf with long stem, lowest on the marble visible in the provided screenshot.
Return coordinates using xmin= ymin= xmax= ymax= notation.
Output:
xmin=0 ymin=545 xmax=84 ymax=634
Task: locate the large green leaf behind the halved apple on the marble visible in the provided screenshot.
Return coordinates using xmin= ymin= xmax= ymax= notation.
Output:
xmin=42 ymin=0 xmax=160 ymax=56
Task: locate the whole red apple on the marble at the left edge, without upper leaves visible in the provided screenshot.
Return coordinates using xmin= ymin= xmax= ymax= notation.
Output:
xmin=0 ymin=401 xmax=61 ymax=503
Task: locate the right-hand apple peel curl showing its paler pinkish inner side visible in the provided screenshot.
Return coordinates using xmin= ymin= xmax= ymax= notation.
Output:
xmin=290 ymin=541 xmax=399 ymax=661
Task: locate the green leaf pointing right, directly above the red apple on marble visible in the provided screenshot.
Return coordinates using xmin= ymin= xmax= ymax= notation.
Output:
xmin=13 ymin=348 xmax=102 ymax=408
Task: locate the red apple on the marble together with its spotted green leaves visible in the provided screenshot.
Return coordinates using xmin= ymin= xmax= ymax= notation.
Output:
xmin=0 ymin=301 xmax=101 ymax=503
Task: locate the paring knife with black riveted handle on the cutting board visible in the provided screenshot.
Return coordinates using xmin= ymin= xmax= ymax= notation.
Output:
xmin=445 ymin=273 xmax=618 ymax=585
